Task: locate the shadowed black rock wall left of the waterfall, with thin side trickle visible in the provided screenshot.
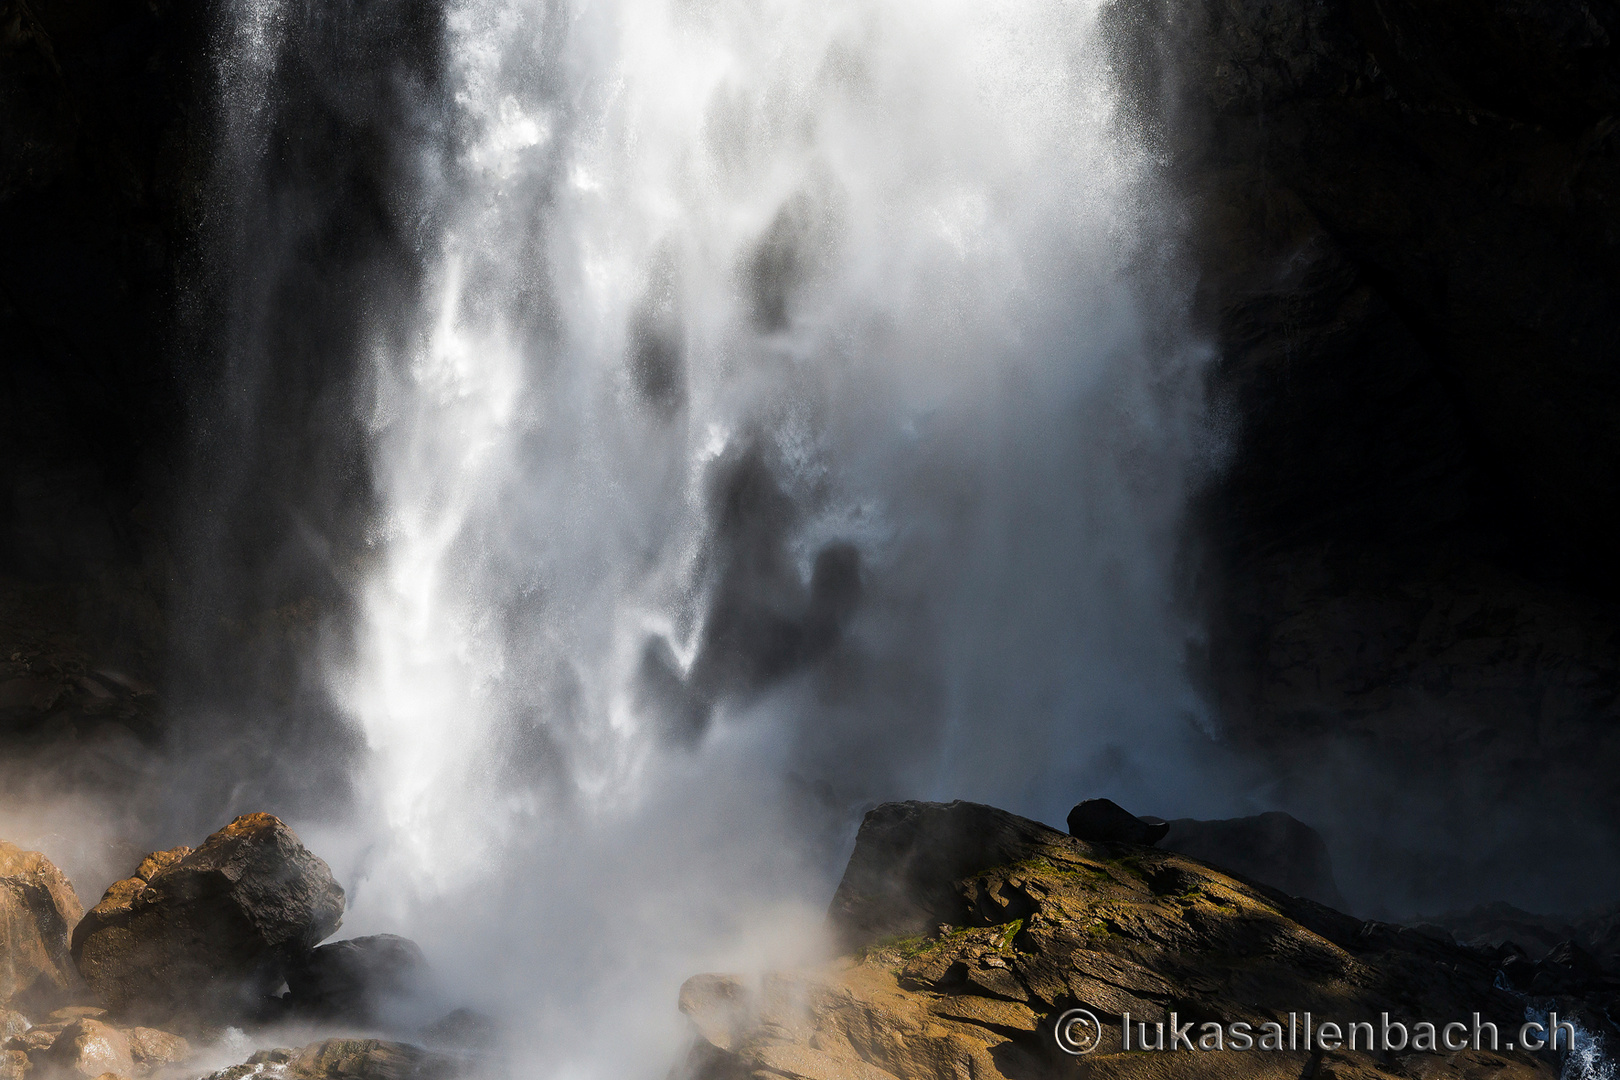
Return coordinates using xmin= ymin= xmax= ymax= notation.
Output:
xmin=0 ymin=0 xmax=450 ymax=827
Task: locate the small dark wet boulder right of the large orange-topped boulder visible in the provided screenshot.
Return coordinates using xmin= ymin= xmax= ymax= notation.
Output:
xmin=287 ymin=934 xmax=428 ymax=1023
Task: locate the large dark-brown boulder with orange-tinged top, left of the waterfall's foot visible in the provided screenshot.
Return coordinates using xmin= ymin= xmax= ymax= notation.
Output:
xmin=73 ymin=814 xmax=343 ymax=1027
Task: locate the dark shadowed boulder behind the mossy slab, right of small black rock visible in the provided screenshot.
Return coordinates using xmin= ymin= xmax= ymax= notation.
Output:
xmin=1162 ymin=810 xmax=1345 ymax=908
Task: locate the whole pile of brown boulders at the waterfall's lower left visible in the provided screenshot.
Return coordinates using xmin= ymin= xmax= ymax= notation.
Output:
xmin=0 ymin=813 xmax=496 ymax=1080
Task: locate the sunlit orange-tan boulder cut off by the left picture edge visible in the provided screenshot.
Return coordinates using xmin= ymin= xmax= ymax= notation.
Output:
xmin=0 ymin=840 xmax=84 ymax=1015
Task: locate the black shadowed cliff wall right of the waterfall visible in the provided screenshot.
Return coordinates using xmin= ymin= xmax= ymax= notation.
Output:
xmin=1155 ymin=0 xmax=1620 ymax=905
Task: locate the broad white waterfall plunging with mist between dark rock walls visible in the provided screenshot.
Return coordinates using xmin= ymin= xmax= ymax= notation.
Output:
xmin=301 ymin=0 xmax=1224 ymax=1077
